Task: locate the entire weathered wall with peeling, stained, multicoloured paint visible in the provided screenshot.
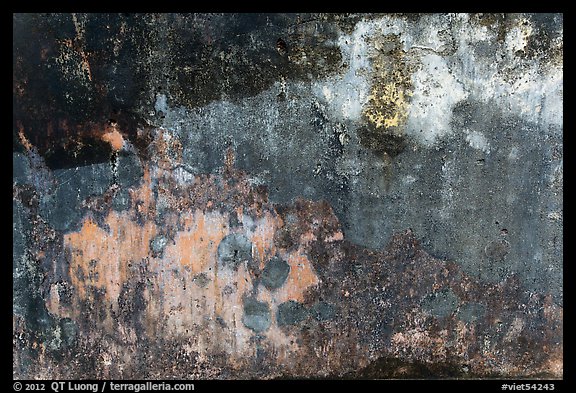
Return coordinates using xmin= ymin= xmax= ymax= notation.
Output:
xmin=13 ymin=14 xmax=563 ymax=378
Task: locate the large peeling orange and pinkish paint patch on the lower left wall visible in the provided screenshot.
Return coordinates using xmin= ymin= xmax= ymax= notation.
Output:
xmin=56 ymin=152 xmax=324 ymax=359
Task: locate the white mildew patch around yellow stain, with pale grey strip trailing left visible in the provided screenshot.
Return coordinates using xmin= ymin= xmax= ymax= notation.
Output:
xmin=155 ymin=14 xmax=563 ymax=152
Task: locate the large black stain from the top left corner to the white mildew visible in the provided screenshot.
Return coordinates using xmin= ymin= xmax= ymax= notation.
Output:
xmin=13 ymin=13 xmax=342 ymax=169
